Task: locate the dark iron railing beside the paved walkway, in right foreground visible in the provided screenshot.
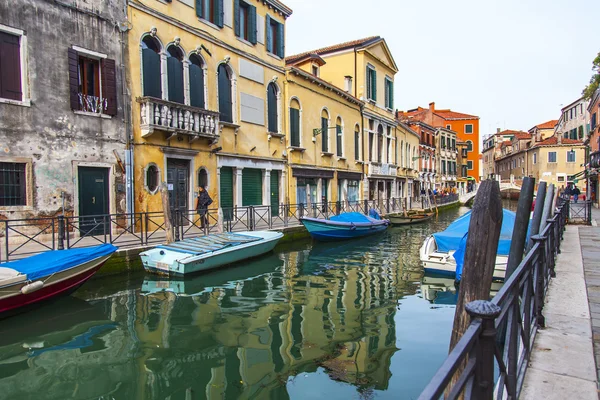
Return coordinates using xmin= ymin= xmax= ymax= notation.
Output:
xmin=419 ymin=200 xmax=569 ymax=399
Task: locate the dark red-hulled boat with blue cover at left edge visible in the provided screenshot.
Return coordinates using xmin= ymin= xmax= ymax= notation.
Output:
xmin=0 ymin=244 xmax=117 ymax=318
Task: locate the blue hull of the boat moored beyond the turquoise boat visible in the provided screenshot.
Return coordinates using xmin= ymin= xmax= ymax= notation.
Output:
xmin=300 ymin=218 xmax=388 ymax=241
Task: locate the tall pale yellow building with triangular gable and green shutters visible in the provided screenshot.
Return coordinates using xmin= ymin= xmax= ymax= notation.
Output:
xmin=286 ymin=36 xmax=398 ymax=200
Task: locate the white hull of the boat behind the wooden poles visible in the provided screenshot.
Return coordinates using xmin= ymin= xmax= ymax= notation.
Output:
xmin=419 ymin=236 xmax=508 ymax=280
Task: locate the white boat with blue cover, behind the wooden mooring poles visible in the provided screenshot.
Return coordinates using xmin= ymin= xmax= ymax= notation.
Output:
xmin=419 ymin=210 xmax=516 ymax=280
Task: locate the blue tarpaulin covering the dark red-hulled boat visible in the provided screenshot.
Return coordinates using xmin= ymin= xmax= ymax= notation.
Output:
xmin=0 ymin=244 xmax=117 ymax=280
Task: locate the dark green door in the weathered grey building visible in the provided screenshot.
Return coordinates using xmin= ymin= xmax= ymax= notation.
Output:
xmin=78 ymin=167 xmax=109 ymax=235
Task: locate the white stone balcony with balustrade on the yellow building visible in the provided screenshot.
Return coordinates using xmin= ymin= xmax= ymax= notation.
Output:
xmin=137 ymin=96 xmax=220 ymax=143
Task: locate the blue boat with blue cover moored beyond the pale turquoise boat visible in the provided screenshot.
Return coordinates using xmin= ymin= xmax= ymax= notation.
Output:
xmin=300 ymin=212 xmax=390 ymax=241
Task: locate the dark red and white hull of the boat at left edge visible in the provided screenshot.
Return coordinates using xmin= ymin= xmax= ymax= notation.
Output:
xmin=0 ymin=255 xmax=111 ymax=318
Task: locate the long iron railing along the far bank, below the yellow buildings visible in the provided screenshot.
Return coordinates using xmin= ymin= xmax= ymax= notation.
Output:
xmin=0 ymin=196 xmax=458 ymax=262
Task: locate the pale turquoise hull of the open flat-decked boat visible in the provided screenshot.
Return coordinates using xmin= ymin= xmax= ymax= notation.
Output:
xmin=140 ymin=231 xmax=283 ymax=276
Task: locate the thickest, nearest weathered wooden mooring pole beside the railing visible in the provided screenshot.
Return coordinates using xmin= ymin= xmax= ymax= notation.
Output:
xmin=449 ymin=179 xmax=502 ymax=396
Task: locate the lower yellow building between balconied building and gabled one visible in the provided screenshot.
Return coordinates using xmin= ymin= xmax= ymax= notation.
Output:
xmin=285 ymin=54 xmax=364 ymax=204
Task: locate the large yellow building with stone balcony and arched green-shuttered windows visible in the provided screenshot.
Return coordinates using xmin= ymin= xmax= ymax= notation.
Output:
xmin=128 ymin=0 xmax=291 ymax=219
